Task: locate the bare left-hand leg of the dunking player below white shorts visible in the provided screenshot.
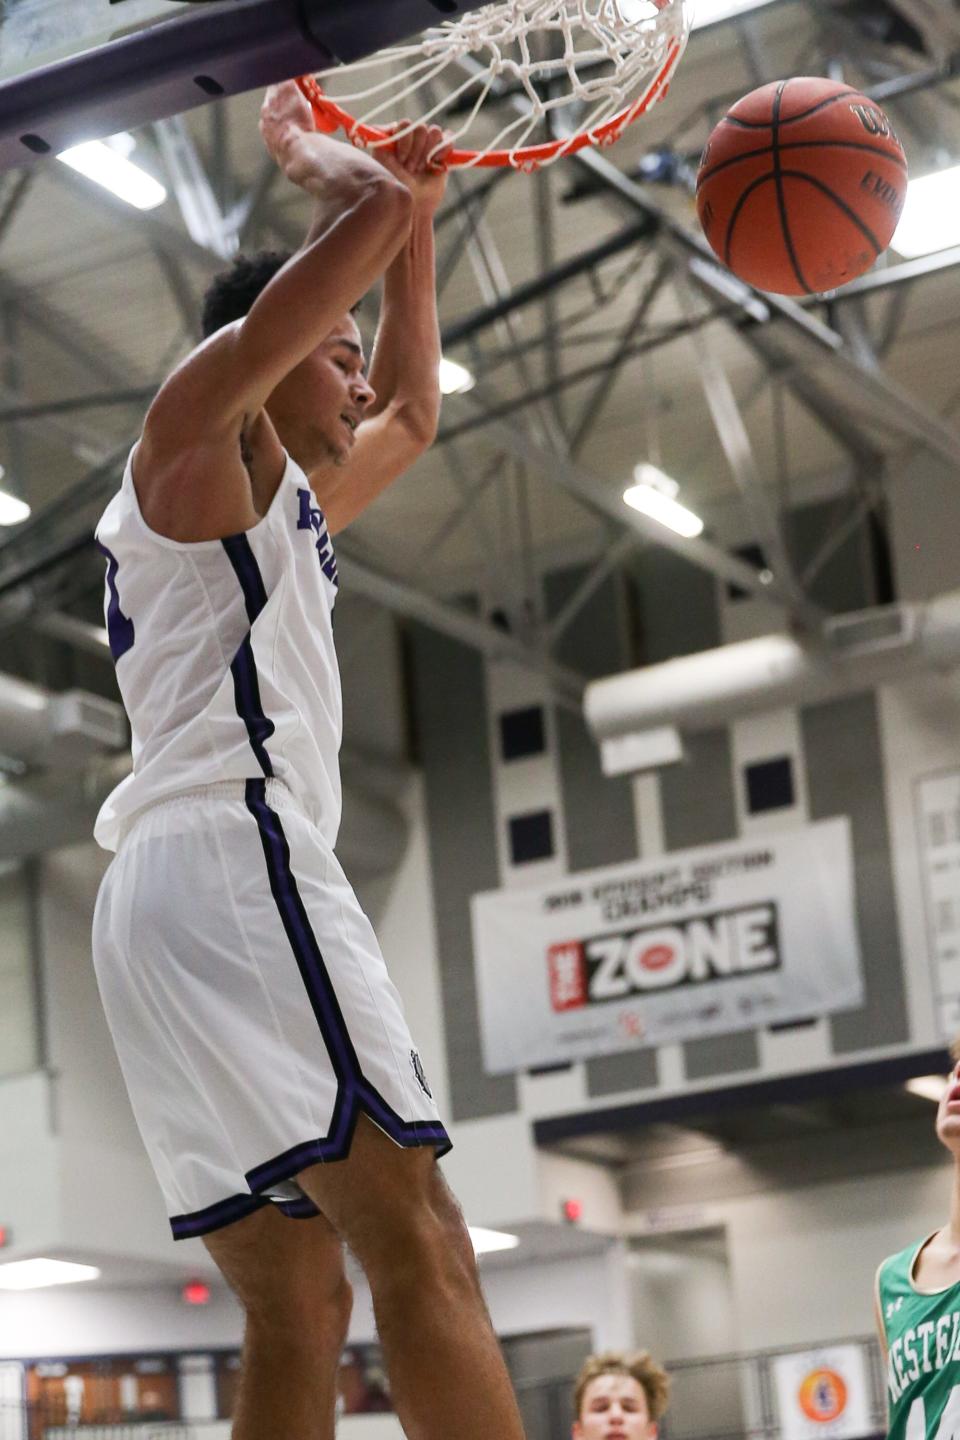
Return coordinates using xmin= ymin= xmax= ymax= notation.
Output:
xmin=204 ymin=1207 xmax=351 ymax=1440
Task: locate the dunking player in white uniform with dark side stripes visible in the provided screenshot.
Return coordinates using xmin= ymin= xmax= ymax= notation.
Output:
xmin=94 ymin=84 xmax=522 ymax=1440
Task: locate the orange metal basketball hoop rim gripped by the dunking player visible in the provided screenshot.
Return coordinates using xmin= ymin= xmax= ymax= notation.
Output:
xmin=296 ymin=37 xmax=684 ymax=171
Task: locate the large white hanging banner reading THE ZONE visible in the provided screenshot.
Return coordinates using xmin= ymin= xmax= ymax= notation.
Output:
xmin=472 ymin=819 xmax=864 ymax=1074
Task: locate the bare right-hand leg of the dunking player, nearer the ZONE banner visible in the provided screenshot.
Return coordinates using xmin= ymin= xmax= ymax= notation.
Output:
xmin=298 ymin=1116 xmax=522 ymax=1440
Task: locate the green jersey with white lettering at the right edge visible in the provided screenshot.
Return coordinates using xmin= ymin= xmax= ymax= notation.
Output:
xmin=878 ymin=1240 xmax=960 ymax=1440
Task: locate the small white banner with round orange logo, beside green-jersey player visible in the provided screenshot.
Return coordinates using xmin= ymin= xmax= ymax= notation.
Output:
xmin=773 ymin=1345 xmax=877 ymax=1440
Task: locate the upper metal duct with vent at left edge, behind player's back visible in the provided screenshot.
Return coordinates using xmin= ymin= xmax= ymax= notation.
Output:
xmin=0 ymin=675 xmax=127 ymax=770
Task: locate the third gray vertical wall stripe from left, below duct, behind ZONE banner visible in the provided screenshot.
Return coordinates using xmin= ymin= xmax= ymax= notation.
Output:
xmin=661 ymin=727 xmax=760 ymax=1080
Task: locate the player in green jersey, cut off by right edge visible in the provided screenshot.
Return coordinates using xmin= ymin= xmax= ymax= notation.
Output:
xmin=877 ymin=1043 xmax=960 ymax=1440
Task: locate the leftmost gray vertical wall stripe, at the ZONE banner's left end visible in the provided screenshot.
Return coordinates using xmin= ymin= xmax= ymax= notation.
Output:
xmin=409 ymin=625 xmax=518 ymax=1120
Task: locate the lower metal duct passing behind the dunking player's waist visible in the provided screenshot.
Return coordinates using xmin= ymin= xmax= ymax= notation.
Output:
xmin=0 ymin=755 xmax=407 ymax=880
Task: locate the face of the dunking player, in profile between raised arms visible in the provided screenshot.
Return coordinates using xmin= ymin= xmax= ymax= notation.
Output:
xmin=269 ymin=315 xmax=376 ymax=469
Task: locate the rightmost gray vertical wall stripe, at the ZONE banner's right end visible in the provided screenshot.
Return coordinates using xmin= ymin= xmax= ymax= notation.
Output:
xmin=800 ymin=691 xmax=910 ymax=1054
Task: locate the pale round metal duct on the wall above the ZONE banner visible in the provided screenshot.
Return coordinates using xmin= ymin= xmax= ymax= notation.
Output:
xmin=584 ymin=590 xmax=960 ymax=742
